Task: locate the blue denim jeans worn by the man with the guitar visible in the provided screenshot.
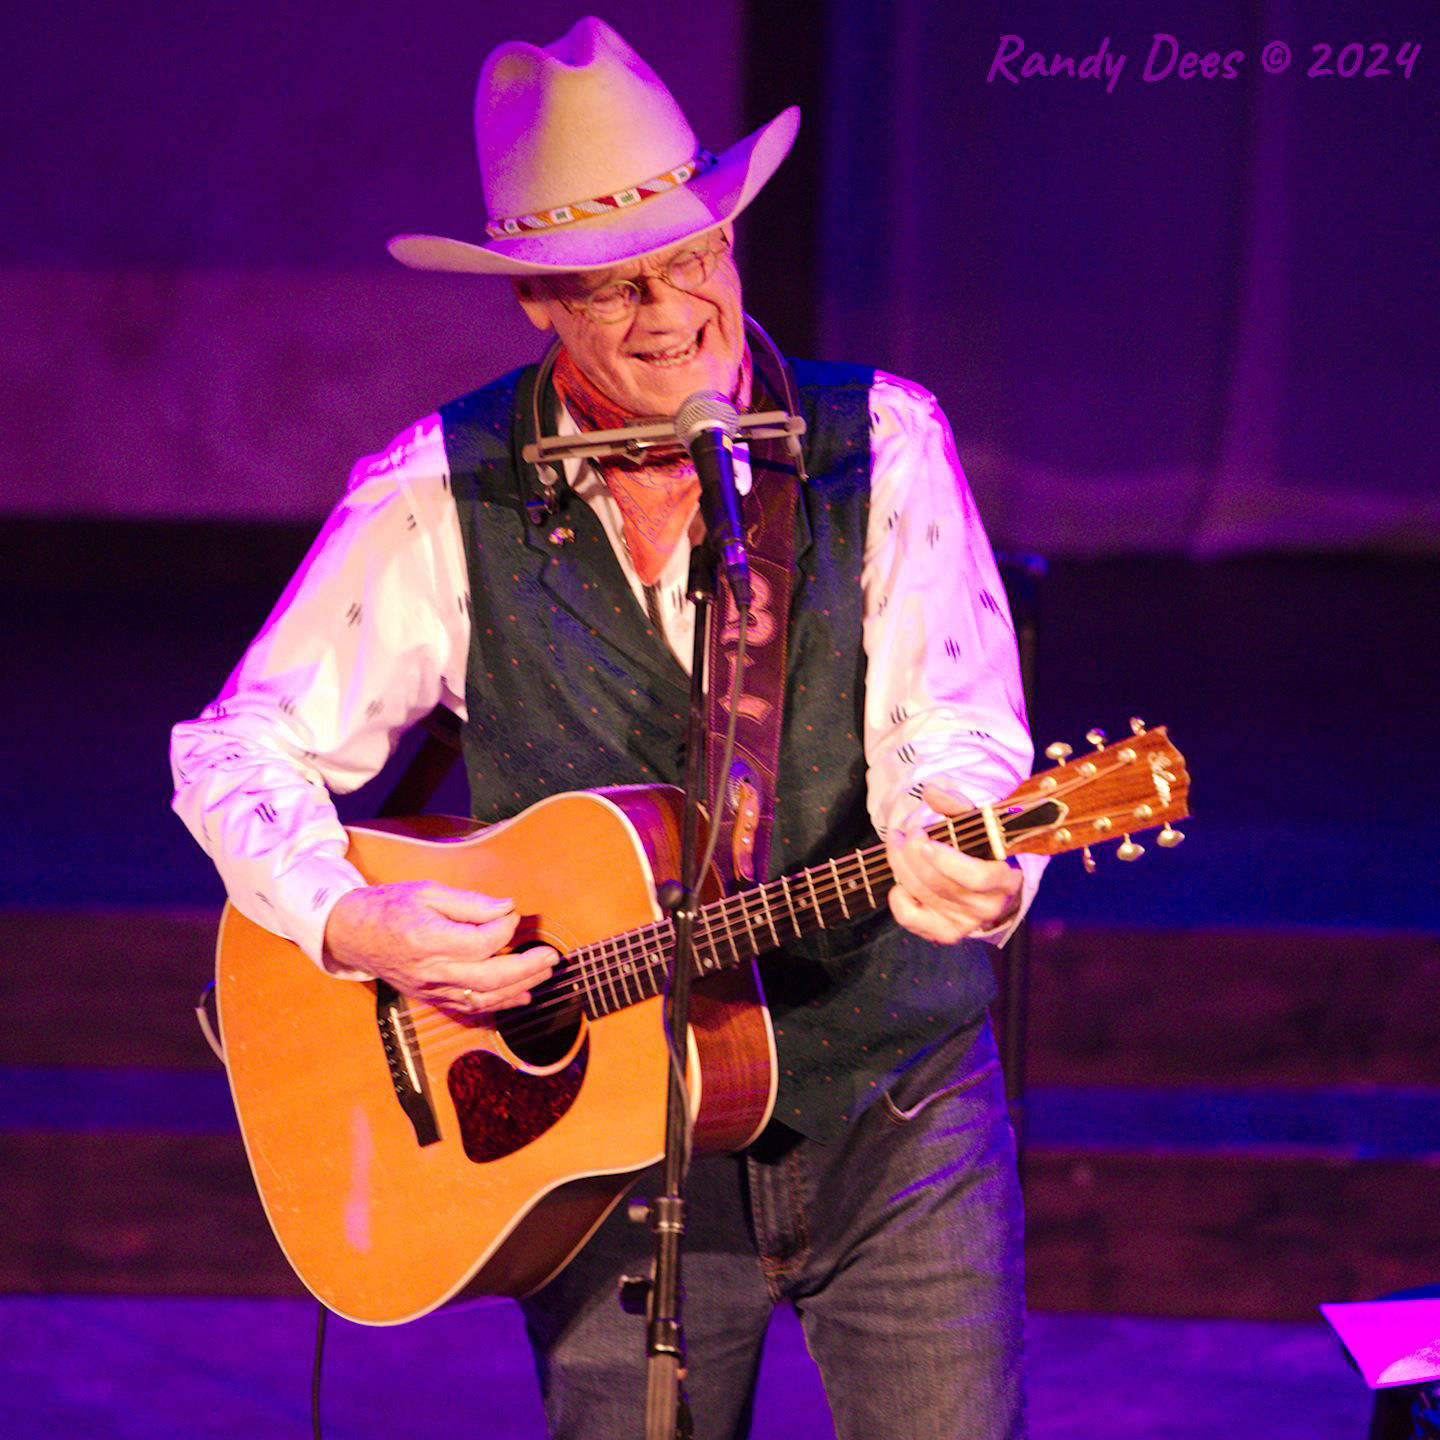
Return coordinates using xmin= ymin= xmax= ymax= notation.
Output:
xmin=523 ymin=1021 xmax=1025 ymax=1440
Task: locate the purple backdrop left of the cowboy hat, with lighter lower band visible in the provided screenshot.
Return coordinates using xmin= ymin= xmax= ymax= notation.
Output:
xmin=0 ymin=0 xmax=742 ymax=518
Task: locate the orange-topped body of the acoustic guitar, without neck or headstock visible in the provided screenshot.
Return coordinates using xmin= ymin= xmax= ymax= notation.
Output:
xmin=217 ymin=786 xmax=775 ymax=1325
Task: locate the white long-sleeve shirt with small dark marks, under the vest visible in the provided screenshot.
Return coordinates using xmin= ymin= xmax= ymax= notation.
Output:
xmin=171 ymin=373 xmax=1044 ymax=963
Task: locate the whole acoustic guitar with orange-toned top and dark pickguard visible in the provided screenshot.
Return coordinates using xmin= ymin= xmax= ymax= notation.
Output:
xmin=216 ymin=721 xmax=1189 ymax=1325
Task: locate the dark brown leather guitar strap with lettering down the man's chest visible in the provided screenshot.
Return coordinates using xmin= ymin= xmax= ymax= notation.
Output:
xmin=706 ymin=373 xmax=798 ymax=891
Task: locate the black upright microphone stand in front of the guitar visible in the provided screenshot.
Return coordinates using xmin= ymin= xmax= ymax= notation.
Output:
xmin=622 ymin=536 xmax=725 ymax=1440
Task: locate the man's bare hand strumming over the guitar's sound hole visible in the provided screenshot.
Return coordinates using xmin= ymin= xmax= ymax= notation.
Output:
xmin=324 ymin=880 xmax=560 ymax=1020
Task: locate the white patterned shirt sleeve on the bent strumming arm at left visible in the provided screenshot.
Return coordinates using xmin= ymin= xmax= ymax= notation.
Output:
xmin=170 ymin=415 xmax=469 ymax=978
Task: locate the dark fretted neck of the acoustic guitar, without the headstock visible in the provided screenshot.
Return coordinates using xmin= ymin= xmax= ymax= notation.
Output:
xmin=572 ymin=805 xmax=1057 ymax=1018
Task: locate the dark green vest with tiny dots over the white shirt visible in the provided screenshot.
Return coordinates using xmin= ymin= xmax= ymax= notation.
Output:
xmin=441 ymin=363 xmax=994 ymax=1139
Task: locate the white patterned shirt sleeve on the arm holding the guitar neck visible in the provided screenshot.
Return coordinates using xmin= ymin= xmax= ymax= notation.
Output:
xmin=861 ymin=373 xmax=1045 ymax=943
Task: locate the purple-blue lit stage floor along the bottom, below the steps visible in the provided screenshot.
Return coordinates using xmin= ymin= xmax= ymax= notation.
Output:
xmin=0 ymin=1296 xmax=1369 ymax=1440
